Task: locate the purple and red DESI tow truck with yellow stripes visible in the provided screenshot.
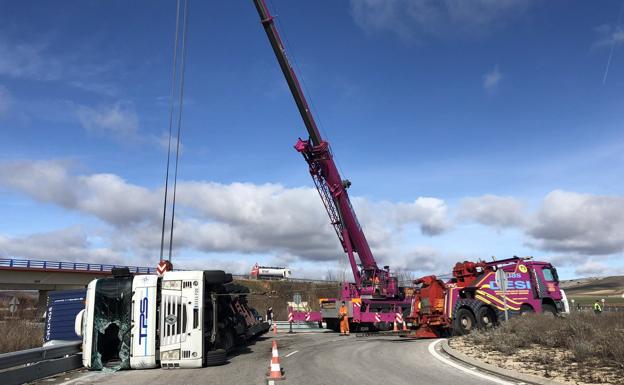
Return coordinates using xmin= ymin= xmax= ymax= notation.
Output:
xmin=406 ymin=257 xmax=570 ymax=337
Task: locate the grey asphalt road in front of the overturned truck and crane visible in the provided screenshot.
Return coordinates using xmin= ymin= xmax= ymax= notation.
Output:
xmin=39 ymin=333 xmax=515 ymax=385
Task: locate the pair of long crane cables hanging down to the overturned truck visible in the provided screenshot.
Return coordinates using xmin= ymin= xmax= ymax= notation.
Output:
xmin=160 ymin=0 xmax=189 ymax=262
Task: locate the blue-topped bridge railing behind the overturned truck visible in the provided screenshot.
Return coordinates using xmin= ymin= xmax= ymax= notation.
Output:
xmin=0 ymin=258 xmax=156 ymax=274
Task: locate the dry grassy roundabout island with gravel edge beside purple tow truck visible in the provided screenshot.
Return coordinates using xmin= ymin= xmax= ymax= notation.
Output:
xmin=449 ymin=312 xmax=624 ymax=385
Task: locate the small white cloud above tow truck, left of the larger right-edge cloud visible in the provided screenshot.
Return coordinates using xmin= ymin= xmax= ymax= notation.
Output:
xmin=458 ymin=194 xmax=526 ymax=229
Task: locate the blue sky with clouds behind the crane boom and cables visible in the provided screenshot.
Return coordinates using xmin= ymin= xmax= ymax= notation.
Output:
xmin=0 ymin=0 xmax=624 ymax=278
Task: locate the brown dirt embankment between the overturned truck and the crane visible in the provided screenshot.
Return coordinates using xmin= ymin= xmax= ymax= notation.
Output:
xmin=235 ymin=280 xmax=340 ymax=321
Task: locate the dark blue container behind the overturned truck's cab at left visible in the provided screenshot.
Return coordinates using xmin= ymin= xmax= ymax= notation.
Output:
xmin=43 ymin=289 xmax=87 ymax=343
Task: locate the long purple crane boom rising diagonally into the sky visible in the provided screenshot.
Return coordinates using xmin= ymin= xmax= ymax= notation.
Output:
xmin=253 ymin=0 xmax=398 ymax=297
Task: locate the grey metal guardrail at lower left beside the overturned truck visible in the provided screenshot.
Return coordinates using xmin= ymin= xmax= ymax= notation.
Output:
xmin=0 ymin=341 xmax=82 ymax=385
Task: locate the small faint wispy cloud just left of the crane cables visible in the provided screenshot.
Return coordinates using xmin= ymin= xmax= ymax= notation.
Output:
xmin=76 ymin=103 xmax=139 ymax=140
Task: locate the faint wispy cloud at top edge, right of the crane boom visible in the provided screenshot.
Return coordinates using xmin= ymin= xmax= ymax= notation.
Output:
xmin=351 ymin=0 xmax=531 ymax=40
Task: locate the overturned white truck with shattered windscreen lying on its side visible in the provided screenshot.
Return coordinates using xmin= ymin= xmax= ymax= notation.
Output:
xmin=76 ymin=270 xmax=269 ymax=370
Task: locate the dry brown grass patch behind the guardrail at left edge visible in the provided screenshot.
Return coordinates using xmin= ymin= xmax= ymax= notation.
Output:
xmin=0 ymin=319 xmax=43 ymax=353
